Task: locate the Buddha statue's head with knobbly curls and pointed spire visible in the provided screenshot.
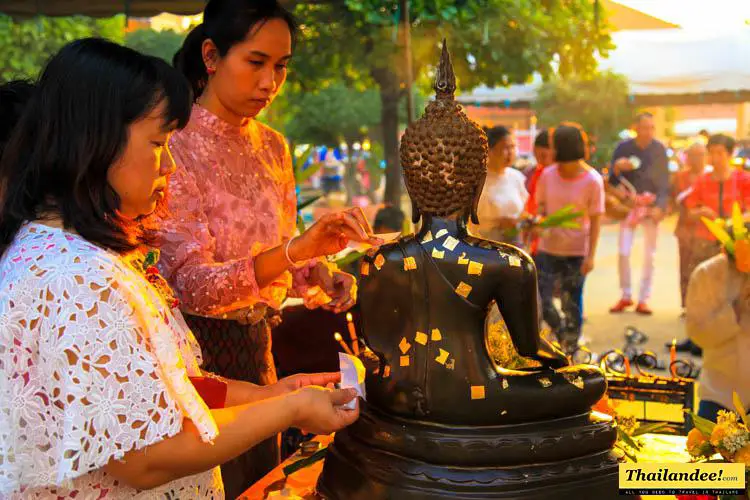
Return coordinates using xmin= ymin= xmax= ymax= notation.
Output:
xmin=401 ymin=40 xmax=489 ymax=224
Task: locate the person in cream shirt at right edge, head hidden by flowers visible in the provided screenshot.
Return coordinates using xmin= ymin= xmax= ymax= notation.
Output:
xmin=685 ymin=234 xmax=750 ymax=422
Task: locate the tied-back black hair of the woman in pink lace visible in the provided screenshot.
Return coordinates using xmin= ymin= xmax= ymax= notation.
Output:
xmin=173 ymin=0 xmax=298 ymax=99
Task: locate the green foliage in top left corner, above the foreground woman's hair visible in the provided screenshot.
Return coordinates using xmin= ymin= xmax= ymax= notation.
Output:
xmin=0 ymin=15 xmax=125 ymax=81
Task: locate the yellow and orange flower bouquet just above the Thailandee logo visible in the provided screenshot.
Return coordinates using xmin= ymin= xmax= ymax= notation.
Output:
xmin=683 ymin=392 xmax=750 ymax=500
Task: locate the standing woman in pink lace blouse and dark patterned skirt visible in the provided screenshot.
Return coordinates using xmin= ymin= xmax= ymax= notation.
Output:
xmin=161 ymin=0 xmax=377 ymax=498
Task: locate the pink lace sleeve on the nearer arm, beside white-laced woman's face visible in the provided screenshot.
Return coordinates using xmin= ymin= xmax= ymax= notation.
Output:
xmin=159 ymin=146 xmax=259 ymax=316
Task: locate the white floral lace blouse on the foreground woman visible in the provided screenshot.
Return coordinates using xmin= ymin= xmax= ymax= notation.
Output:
xmin=0 ymin=223 xmax=224 ymax=499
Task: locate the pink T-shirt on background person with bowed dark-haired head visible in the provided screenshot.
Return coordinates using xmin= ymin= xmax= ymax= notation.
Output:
xmin=537 ymin=165 xmax=604 ymax=257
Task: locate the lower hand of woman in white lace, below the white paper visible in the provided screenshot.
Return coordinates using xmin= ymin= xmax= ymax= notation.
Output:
xmin=291 ymin=386 xmax=359 ymax=434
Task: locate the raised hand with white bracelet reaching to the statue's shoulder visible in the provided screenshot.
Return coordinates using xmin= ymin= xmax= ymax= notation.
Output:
xmin=289 ymin=207 xmax=383 ymax=262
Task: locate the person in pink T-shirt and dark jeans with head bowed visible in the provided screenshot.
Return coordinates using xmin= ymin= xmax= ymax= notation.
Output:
xmin=535 ymin=123 xmax=604 ymax=353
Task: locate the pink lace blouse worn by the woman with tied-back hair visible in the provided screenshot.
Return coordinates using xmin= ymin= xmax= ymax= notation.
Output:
xmin=159 ymin=104 xmax=320 ymax=317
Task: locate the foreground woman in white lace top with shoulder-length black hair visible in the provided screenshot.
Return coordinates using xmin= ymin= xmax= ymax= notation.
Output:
xmin=0 ymin=39 xmax=358 ymax=499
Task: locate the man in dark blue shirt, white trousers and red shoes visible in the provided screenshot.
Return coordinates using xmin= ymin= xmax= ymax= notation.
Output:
xmin=609 ymin=113 xmax=669 ymax=315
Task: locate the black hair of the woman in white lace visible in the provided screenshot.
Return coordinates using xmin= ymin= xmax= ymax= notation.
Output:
xmin=0 ymin=38 xmax=192 ymax=252
